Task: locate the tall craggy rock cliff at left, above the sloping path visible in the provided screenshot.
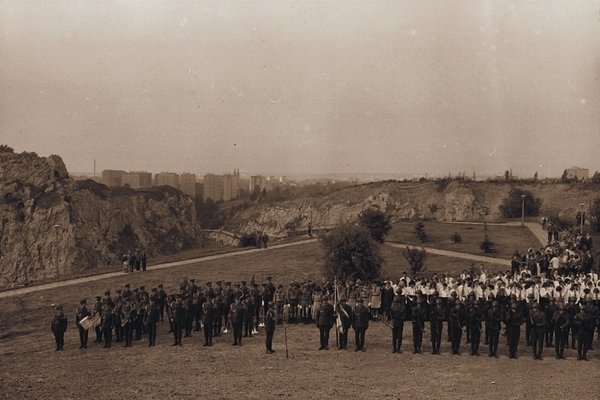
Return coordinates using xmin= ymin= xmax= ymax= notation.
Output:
xmin=0 ymin=153 xmax=198 ymax=287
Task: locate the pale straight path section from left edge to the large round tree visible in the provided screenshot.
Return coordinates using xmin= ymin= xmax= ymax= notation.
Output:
xmin=0 ymin=239 xmax=317 ymax=299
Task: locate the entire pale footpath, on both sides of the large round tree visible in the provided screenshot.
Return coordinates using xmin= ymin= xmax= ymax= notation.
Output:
xmin=0 ymin=222 xmax=547 ymax=299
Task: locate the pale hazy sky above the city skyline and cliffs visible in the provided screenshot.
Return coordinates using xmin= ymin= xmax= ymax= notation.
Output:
xmin=0 ymin=0 xmax=600 ymax=176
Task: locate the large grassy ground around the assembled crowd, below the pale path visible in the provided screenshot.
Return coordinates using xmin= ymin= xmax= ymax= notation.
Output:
xmin=0 ymin=243 xmax=600 ymax=399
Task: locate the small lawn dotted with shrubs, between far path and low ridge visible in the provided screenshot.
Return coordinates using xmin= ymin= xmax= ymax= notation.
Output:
xmin=387 ymin=221 xmax=541 ymax=259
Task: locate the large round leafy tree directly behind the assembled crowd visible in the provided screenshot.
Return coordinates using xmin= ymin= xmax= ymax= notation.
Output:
xmin=321 ymin=223 xmax=383 ymax=281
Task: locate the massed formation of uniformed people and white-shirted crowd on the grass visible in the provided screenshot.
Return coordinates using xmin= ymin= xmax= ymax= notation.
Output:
xmin=52 ymin=267 xmax=600 ymax=360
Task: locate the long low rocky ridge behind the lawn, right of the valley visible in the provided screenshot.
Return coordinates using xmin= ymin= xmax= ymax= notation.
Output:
xmin=225 ymin=181 xmax=600 ymax=237
